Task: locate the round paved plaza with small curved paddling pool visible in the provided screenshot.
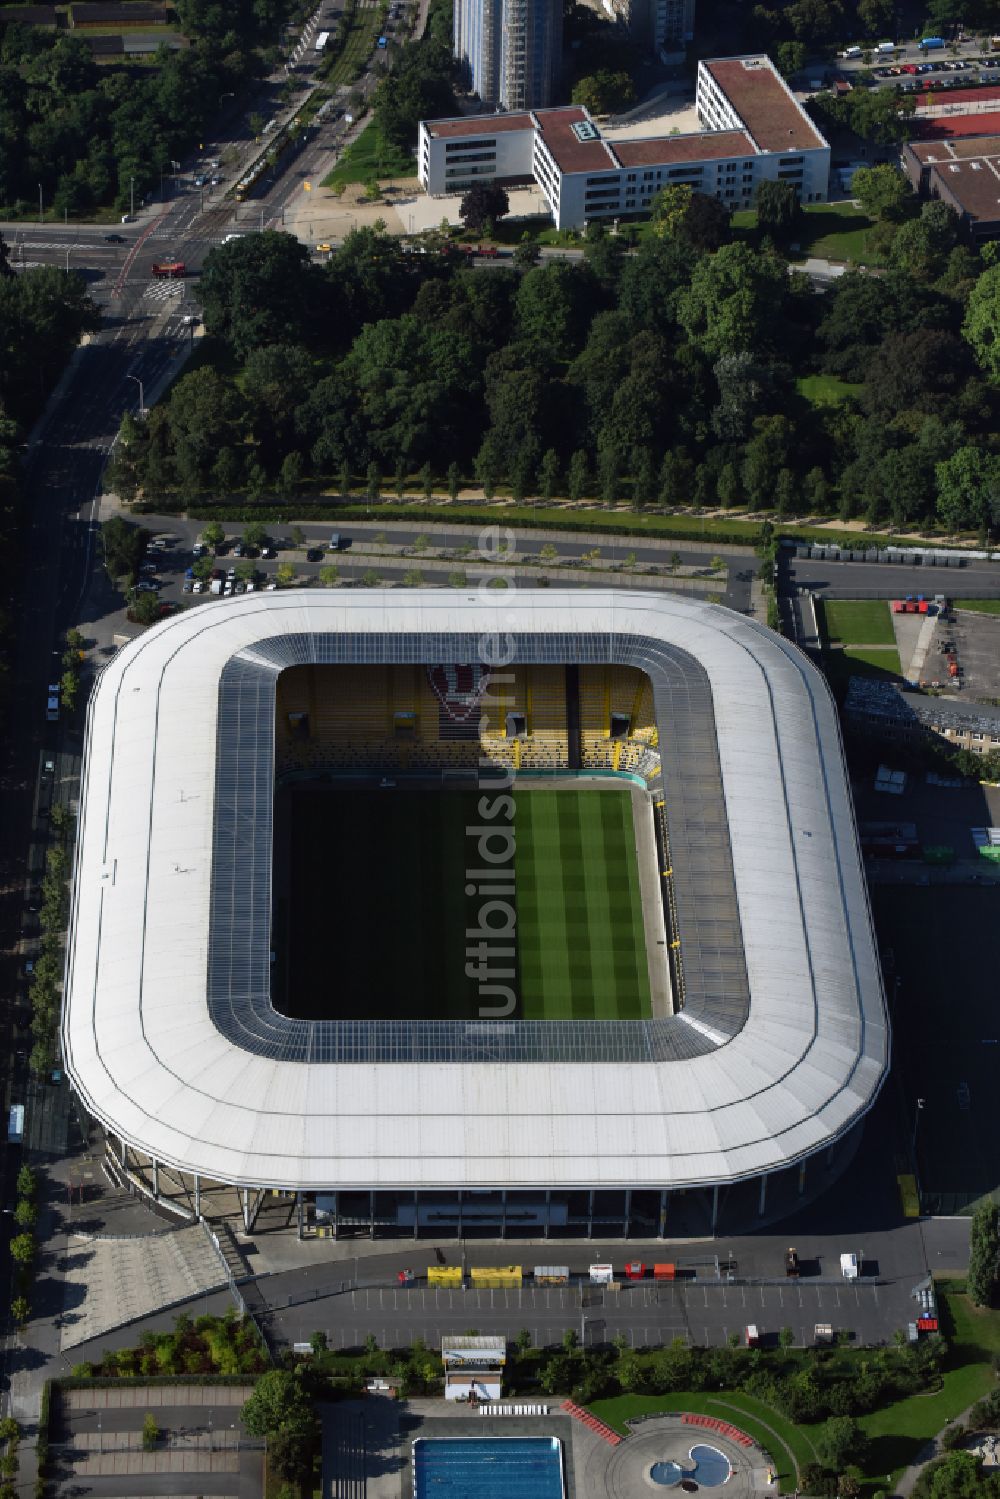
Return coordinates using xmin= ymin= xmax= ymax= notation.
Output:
xmin=604 ymin=1415 xmax=778 ymax=1499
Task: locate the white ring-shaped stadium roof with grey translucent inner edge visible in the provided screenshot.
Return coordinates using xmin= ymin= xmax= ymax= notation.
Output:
xmin=63 ymin=589 xmax=889 ymax=1189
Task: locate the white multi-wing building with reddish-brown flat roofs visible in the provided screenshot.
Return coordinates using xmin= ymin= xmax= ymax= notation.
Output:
xmin=418 ymin=57 xmax=829 ymax=229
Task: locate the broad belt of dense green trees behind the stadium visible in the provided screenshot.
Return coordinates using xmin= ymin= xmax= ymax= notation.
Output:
xmin=109 ymin=164 xmax=1000 ymax=531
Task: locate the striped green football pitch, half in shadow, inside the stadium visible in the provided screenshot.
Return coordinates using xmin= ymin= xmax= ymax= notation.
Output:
xmin=282 ymin=787 xmax=649 ymax=1019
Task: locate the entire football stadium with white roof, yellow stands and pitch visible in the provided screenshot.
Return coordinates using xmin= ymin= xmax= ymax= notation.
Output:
xmin=63 ymin=589 xmax=889 ymax=1238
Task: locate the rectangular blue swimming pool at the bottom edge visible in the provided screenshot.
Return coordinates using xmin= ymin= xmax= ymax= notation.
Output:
xmin=414 ymin=1436 xmax=564 ymax=1499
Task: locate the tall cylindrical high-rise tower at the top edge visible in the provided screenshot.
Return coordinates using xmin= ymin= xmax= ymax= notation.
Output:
xmin=454 ymin=0 xmax=562 ymax=109
